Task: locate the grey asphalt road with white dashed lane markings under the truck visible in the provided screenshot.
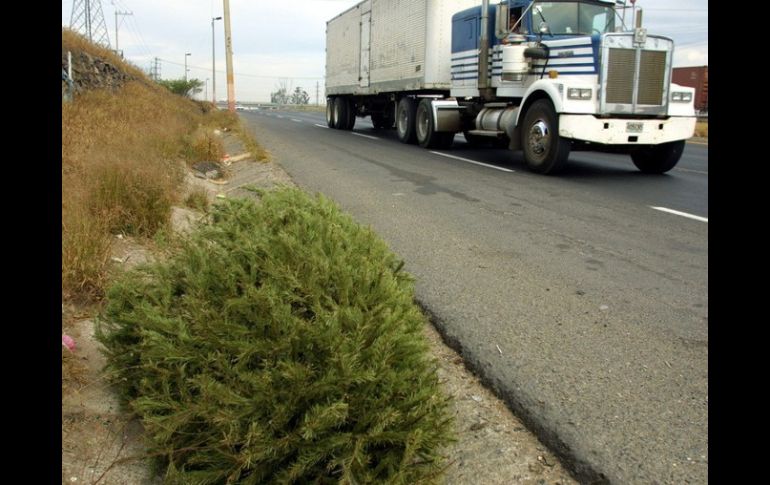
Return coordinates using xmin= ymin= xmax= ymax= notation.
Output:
xmin=241 ymin=111 xmax=708 ymax=484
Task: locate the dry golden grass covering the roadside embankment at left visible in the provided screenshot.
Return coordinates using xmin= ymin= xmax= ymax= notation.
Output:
xmin=62 ymin=29 xmax=266 ymax=300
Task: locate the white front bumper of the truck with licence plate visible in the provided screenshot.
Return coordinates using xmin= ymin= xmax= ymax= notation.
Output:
xmin=559 ymin=114 xmax=696 ymax=145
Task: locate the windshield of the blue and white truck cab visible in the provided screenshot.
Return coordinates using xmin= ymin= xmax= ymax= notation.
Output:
xmin=532 ymin=2 xmax=615 ymax=35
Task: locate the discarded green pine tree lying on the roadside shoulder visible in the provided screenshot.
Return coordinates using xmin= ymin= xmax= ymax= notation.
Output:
xmin=99 ymin=189 xmax=452 ymax=484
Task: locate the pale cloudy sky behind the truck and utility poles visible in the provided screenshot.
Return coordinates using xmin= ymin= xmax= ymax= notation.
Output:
xmin=62 ymin=0 xmax=708 ymax=103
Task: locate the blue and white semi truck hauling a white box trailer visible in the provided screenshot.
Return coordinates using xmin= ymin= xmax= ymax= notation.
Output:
xmin=325 ymin=0 xmax=696 ymax=174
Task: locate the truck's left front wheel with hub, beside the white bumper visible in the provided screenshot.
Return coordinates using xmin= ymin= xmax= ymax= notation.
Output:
xmin=521 ymin=99 xmax=570 ymax=174
